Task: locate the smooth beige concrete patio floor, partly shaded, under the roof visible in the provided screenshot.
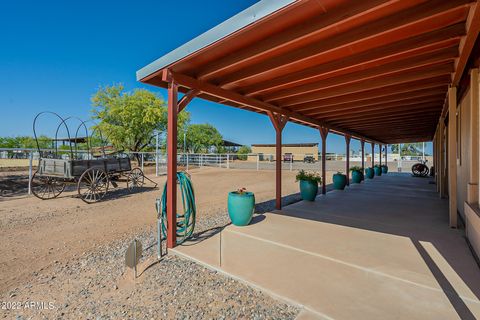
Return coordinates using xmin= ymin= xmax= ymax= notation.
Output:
xmin=173 ymin=173 xmax=480 ymax=319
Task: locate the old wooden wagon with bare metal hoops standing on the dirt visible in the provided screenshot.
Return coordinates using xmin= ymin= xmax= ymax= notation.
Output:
xmin=31 ymin=111 xmax=157 ymax=203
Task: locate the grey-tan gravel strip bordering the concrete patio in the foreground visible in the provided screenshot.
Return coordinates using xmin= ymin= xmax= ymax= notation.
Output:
xmin=0 ymin=202 xmax=299 ymax=319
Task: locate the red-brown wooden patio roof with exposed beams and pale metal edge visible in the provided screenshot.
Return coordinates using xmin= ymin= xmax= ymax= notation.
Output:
xmin=137 ymin=0 xmax=480 ymax=143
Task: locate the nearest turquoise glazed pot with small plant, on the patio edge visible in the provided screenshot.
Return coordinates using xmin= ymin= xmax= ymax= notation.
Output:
xmin=228 ymin=188 xmax=255 ymax=226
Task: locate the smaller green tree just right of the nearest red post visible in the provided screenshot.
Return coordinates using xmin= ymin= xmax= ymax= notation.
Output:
xmin=187 ymin=123 xmax=223 ymax=153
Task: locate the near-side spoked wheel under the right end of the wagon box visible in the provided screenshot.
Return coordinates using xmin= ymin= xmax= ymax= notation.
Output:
xmin=77 ymin=168 xmax=109 ymax=203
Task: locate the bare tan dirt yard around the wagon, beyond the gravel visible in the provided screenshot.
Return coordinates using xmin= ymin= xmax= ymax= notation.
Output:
xmin=0 ymin=168 xmax=331 ymax=315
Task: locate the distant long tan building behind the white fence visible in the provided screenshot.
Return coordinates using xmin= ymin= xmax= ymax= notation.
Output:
xmin=249 ymin=143 xmax=318 ymax=161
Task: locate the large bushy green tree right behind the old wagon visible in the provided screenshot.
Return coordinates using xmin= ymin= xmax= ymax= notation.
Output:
xmin=92 ymin=85 xmax=190 ymax=152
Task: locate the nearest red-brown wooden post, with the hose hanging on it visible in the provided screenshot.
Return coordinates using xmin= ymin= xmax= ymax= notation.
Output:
xmin=167 ymin=80 xmax=178 ymax=248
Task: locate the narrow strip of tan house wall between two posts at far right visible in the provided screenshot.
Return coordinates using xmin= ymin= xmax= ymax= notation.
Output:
xmin=457 ymin=89 xmax=471 ymax=219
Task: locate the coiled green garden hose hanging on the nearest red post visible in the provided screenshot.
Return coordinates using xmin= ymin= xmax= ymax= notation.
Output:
xmin=156 ymin=171 xmax=197 ymax=244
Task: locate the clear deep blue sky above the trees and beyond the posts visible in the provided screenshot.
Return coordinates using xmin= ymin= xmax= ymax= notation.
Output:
xmin=0 ymin=0 xmax=431 ymax=152
